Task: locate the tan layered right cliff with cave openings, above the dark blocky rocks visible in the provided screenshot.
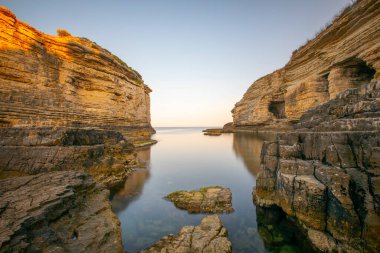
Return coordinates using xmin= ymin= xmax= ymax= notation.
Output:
xmin=232 ymin=0 xmax=380 ymax=128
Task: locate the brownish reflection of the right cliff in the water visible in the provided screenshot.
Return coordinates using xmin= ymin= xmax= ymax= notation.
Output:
xmin=233 ymin=133 xmax=274 ymax=177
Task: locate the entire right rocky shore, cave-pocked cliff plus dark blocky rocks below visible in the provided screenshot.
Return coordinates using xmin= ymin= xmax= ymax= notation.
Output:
xmin=226 ymin=0 xmax=380 ymax=252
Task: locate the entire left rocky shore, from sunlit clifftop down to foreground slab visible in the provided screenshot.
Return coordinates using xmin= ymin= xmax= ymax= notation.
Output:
xmin=0 ymin=7 xmax=156 ymax=252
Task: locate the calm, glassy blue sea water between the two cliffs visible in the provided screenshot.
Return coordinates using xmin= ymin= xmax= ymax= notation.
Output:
xmin=112 ymin=128 xmax=302 ymax=252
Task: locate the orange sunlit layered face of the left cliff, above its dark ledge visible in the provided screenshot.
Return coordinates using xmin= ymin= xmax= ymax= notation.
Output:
xmin=0 ymin=7 xmax=151 ymax=127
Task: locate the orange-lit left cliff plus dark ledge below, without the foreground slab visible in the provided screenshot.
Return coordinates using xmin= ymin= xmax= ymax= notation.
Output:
xmin=0 ymin=7 xmax=154 ymax=186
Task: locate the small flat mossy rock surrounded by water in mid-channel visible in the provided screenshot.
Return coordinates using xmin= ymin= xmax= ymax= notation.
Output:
xmin=165 ymin=186 xmax=234 ymax=213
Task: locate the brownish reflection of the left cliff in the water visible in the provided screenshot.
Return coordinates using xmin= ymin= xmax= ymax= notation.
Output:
xmin=112 ymin=147 xmax=150 ymax=213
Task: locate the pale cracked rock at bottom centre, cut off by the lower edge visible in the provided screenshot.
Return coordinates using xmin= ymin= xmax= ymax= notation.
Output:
xmin=141 ymin=215 xmax=232 ymax=253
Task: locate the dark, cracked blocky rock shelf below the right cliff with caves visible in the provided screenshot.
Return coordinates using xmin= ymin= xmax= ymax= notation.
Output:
xmin=254 ymin=81 xmax=380 ymax=252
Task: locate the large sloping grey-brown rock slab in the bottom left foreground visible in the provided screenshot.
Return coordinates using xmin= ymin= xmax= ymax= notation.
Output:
xmin=0 ymin=171 xmax=122 ymax=252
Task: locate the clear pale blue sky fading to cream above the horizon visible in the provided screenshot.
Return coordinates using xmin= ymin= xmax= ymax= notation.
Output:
xmin=0 ymin=0 xmax=351 ymax=127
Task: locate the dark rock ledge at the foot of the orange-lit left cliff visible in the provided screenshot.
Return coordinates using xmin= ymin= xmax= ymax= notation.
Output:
xmin=0 ymin=127 xmax=145 ymax=187
